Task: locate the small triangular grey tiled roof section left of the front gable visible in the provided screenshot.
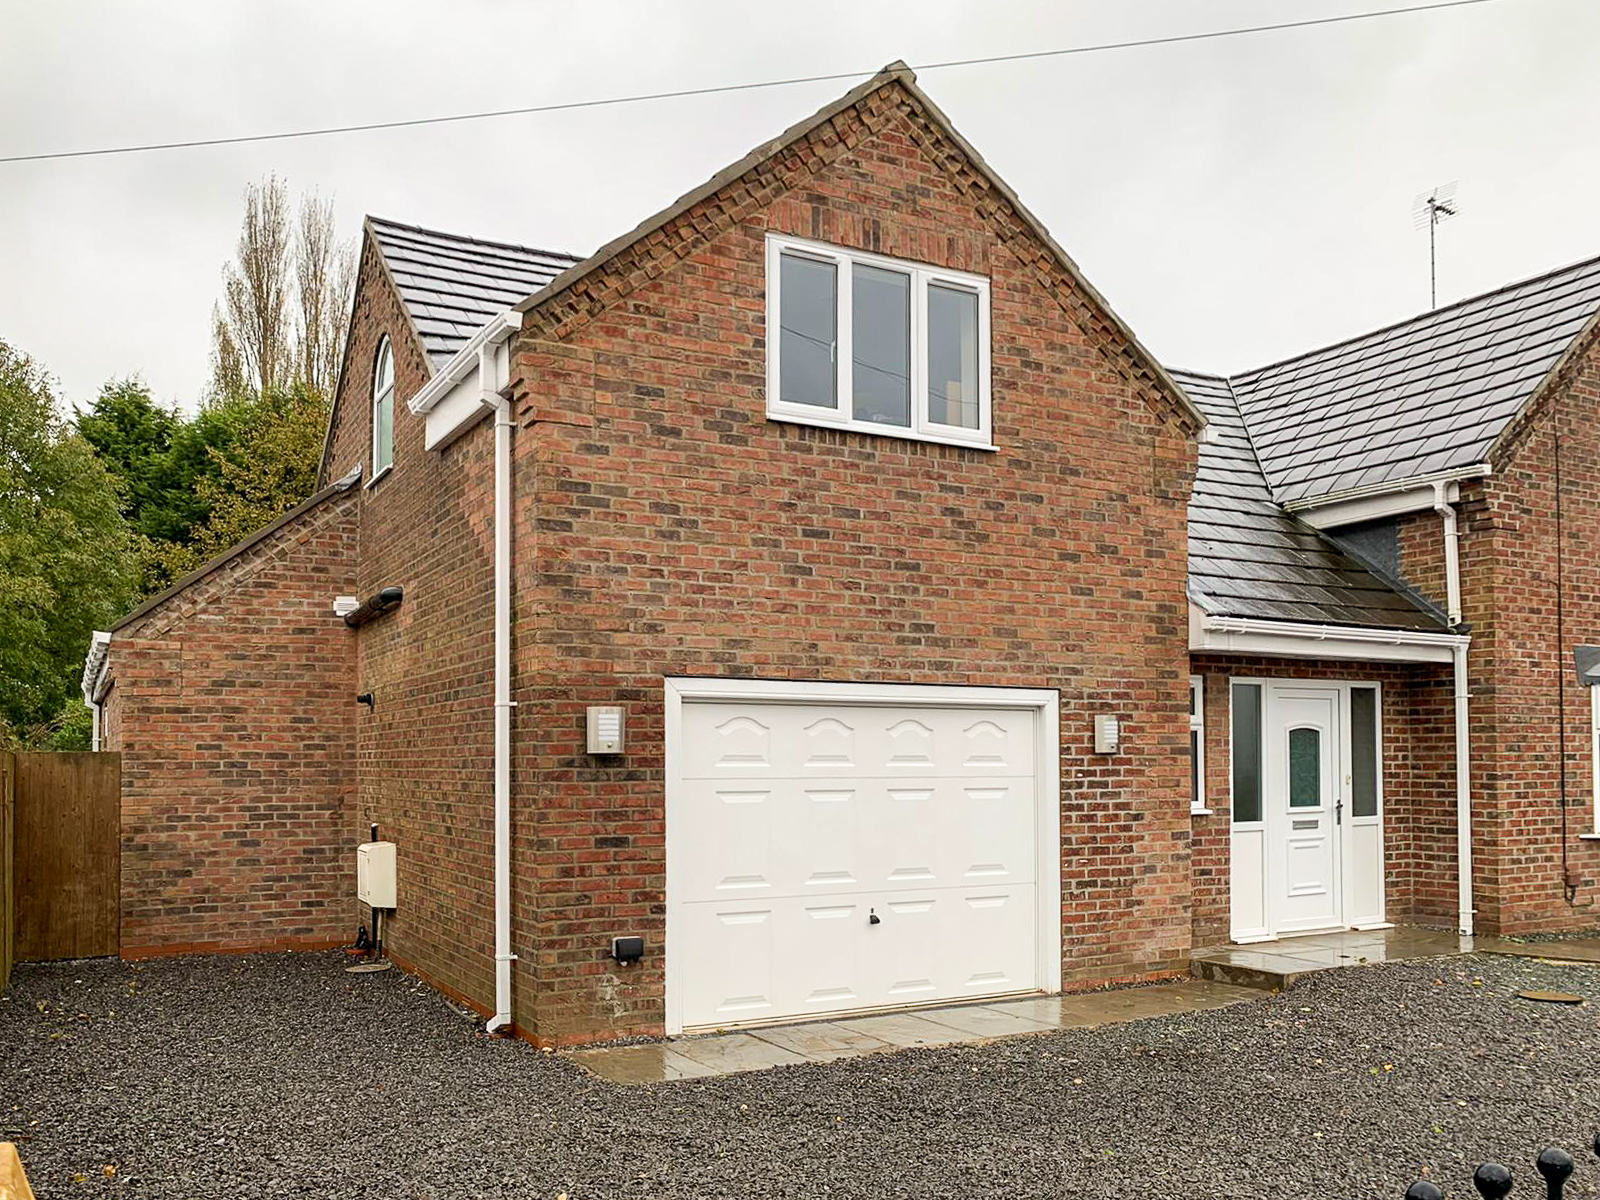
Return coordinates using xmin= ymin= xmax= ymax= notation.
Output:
xmin=366 ymin=216 xmax=581 ymax=368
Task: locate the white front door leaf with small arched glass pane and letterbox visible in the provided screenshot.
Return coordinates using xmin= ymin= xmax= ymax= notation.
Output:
xmin=1266 ymin=685 xmax=1342 ymax=933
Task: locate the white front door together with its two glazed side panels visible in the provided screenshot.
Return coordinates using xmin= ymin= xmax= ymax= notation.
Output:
xmin=1230 ymin=678 xmax=1384 ymax=942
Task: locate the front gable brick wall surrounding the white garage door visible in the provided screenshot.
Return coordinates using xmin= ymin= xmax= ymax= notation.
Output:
xmin=515 ymin=88 xmax=1194 ymax=1042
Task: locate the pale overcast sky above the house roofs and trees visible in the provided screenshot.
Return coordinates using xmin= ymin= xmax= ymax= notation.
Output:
xmin=0 ymin=0 xmax=1600 ymax=408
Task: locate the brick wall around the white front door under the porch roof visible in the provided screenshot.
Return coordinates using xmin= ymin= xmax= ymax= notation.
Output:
xmin=1192 ymin=654 xmax=1456 ymax=946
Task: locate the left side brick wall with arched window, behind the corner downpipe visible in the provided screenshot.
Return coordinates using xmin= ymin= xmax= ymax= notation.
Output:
xmin=323 ymin=235 xmax=499 ymax=1008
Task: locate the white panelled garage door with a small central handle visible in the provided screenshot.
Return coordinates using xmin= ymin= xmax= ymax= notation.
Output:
xmin=667 ymin=685 xmax=1059 ymax=1032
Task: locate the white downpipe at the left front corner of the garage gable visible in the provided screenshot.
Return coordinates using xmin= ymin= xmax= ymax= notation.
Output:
xmin=478 ymin=339 xmax=517 ymax=1034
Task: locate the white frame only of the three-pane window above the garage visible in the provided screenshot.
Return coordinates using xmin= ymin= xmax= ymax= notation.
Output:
xmin=766 ymin=234 xmax=994 ymax=450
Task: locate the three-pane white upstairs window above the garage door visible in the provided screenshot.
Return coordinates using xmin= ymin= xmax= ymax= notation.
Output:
xmin=766 ymin=235 xmax=992 ymax=446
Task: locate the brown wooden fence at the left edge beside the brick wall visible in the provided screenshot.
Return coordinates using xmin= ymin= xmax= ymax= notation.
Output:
xmin=0 ymin=754 xmax=122 ymax=979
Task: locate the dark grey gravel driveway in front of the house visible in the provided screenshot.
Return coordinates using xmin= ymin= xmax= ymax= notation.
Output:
xmin=0 ymin=954 xmax=1600 ymax=1200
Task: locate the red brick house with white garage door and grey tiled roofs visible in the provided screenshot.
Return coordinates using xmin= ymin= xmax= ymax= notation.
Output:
xmin=85 ymin=66 xmax=1600 ymax=1043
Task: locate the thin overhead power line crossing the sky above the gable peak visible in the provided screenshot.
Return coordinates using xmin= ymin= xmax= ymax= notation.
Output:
xmin=0 ymin=0 xmax=1496 ymax=163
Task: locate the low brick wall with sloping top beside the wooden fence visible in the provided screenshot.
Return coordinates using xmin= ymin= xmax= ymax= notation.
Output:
xmin=102 ymin=493 xmax=357 ymax=957
